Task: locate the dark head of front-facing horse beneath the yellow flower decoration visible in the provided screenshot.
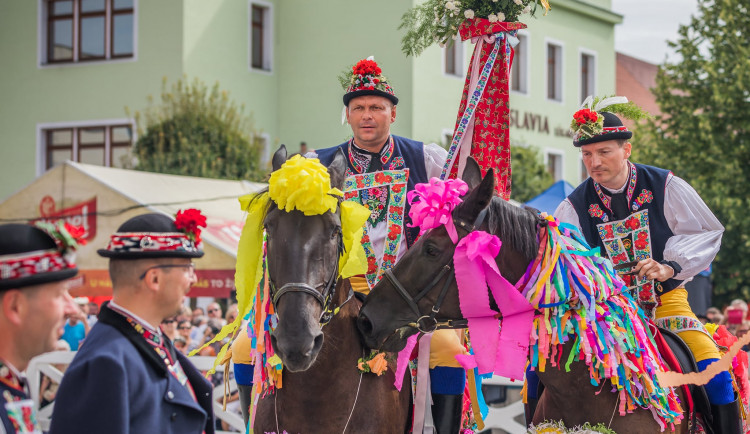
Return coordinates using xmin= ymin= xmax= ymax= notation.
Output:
xmin=263 ymin=145 xmax=346 ymax=372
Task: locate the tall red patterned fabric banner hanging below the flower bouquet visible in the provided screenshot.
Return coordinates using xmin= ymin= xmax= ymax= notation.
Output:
xmin=443 ymin=18 xmax=526 ymax=200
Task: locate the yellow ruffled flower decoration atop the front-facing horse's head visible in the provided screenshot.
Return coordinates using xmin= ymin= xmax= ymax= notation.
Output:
xmin=268 ymin=155 xmax=344 ymax=215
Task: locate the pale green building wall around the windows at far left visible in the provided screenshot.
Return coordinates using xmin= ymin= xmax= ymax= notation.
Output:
xmin=0 ymin=0 xmax=183 ymax=199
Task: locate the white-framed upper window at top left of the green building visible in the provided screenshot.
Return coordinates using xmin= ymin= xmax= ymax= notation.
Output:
xmin=36 ymin=0 xmax=138 ymax=69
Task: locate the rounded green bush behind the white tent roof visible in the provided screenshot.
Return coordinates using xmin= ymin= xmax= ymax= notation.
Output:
xmin=135 ymin=77 xmax=264 ymax=180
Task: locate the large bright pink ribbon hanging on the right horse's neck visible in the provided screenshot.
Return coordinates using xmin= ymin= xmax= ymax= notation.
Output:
xmin=453 ymin=231 xmax=534 ymax=380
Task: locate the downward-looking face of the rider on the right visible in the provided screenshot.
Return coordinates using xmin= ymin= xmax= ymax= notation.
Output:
xmin=581 ymin=140 xmax=631 ymax=188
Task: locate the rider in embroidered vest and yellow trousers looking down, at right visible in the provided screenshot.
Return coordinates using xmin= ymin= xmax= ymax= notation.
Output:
xmin=548 ymin=98 xmax=741 ymax=434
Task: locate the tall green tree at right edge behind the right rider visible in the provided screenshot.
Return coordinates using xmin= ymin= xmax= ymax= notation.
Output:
xmin=634 ymin=0 xmax=750 ymax=305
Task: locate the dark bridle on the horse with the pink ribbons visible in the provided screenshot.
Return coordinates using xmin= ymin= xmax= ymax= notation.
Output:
xmin=385 ymin=208 xmax=487 ymax=333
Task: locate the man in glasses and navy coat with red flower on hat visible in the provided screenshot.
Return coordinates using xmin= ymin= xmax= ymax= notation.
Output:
xmin=50 ymin=210 xmax=214 ymax=434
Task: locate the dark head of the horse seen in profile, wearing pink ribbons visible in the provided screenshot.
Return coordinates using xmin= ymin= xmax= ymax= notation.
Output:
xmin=357 ymin=158 xmax=536 ymax=351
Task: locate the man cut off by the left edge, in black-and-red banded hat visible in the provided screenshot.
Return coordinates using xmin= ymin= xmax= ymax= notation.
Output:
xmin=0 ymin=224 xmax=78 ymax=433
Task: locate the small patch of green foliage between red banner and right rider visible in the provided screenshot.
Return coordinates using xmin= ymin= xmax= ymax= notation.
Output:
xmin=510 ymin=145 xmax=554 ymax=203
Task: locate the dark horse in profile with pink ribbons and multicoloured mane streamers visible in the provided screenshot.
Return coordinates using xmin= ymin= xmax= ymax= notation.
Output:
xmin=357 ymin=159 xmax=689 ymax=433
